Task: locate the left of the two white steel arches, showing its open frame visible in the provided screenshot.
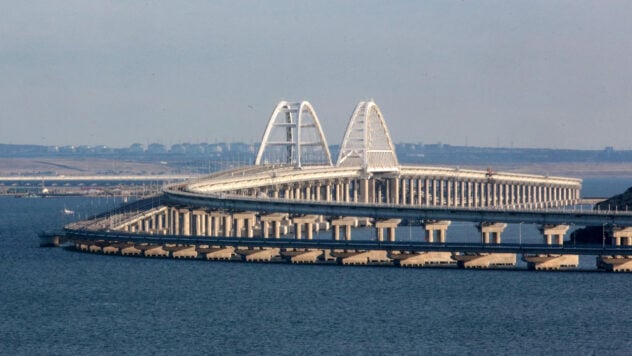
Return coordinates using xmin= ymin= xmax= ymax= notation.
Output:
xmin=255 ymin=101 xmax=333 ymax=168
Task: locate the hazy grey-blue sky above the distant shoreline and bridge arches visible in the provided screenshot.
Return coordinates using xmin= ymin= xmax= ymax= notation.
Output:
xmin=0 ymin=0 xmax=632 ymax=149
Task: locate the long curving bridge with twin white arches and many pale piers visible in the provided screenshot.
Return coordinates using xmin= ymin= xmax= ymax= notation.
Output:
xmin=48 ymin=101 xmax=632 ymax=271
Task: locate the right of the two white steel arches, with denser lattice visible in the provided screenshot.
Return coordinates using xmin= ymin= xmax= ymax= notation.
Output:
xmin=336 ymin=100 xmax=399 ymax=173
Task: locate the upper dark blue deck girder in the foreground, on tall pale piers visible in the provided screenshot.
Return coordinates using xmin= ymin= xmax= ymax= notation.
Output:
xmin=164 ymin=186 xmax=632 ymax=226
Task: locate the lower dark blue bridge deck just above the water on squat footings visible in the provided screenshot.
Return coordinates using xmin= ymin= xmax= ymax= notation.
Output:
xmin=62 ymin=229 xmax=632 ymax=256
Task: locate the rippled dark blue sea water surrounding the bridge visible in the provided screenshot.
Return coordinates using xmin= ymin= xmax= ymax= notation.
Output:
xmin=0 ymin=179 xmax=632 ymax=355
